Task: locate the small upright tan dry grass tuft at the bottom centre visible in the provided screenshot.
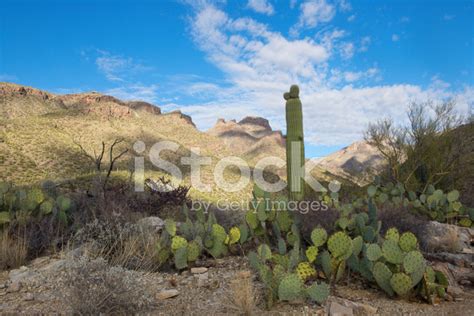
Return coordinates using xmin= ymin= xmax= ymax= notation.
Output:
xmin=227 ymin=271 xmax=257 ymax=316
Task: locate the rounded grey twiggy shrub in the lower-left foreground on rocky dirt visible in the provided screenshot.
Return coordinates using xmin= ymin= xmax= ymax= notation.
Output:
xmin=63 ymin=257 xmax=152 ymax=315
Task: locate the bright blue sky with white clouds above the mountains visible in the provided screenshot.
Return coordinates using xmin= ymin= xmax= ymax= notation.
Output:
xmin=0 ymin=0 xmax=474 ymax=157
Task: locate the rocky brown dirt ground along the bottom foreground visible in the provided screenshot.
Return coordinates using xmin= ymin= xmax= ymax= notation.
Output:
xmin=0 ymin=257 xmax=474 ymax=315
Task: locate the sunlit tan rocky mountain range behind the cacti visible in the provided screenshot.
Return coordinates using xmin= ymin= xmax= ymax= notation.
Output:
xmin=0 ymin=83 xmax=386 ymax=200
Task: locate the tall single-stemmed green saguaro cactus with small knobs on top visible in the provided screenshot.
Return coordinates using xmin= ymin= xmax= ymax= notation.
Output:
xmin=283 ymin=85 xmax=305 ymax=201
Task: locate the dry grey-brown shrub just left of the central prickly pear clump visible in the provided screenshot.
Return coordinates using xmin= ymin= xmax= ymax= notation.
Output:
xmin=71 ymin=219 xmax=158 ymax=271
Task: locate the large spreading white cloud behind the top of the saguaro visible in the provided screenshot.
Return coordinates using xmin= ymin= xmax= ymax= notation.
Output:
xmin=165 ymin=5 xmax=474 ymax=146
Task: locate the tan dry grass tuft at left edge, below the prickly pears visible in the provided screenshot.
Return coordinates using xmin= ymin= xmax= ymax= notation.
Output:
xmin=0 ymin=229 xmax=28 ymax=271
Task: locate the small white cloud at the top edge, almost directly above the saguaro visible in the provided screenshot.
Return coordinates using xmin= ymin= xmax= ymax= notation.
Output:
xmin=290 ymin=0 xmax=336 ymax=36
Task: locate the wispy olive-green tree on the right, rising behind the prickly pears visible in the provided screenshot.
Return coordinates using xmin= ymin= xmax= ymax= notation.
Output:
xmin=364 ymin=100 xmax=463 ymax=190
